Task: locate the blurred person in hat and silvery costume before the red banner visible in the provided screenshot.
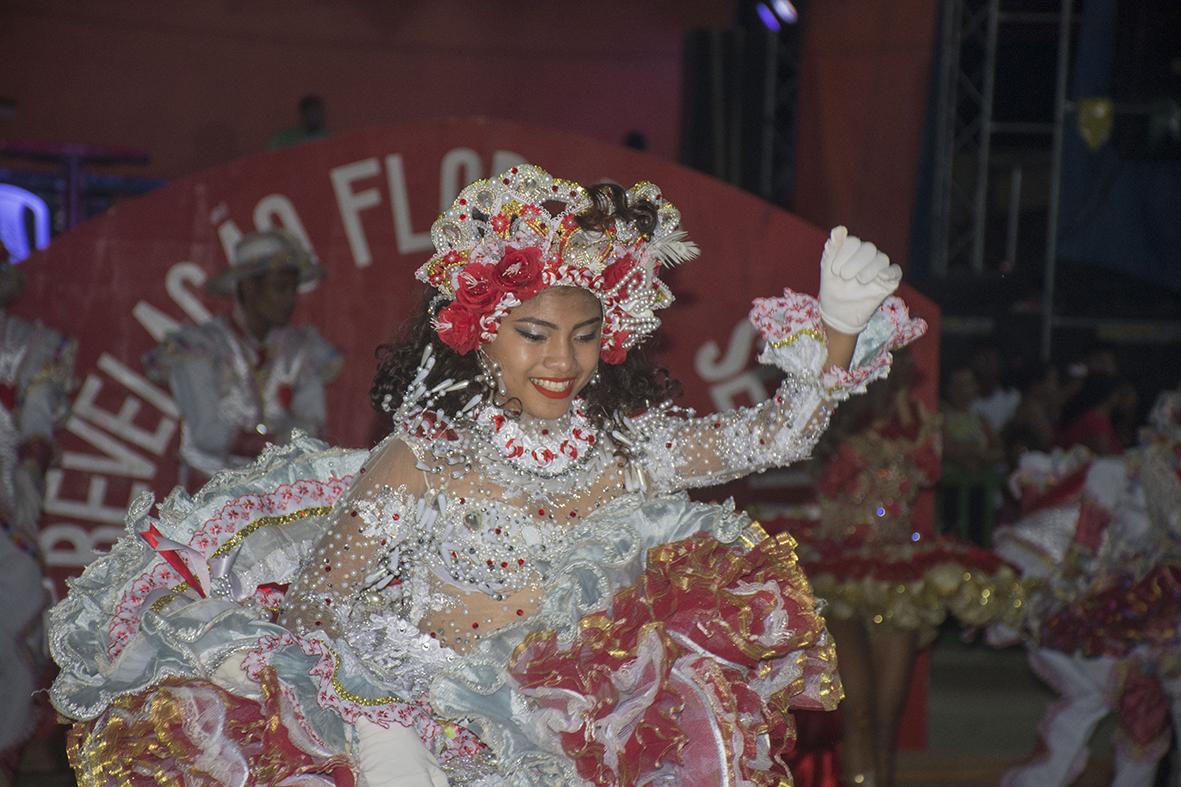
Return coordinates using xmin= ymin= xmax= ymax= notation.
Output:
xmin=144 ymin=229 xmax=341 ymax=487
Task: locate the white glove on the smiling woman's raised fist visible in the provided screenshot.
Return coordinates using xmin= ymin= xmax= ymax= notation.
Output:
xmin=820 ymin=227 xmax=902 ymax=333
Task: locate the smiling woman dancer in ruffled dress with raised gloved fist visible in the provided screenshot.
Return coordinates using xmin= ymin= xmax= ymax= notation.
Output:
xmin=52 ymin=165 xmax=925 ymax=786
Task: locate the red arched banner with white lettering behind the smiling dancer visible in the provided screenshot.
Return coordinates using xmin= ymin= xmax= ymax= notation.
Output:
xmin=17 ymin=119 xmax=938 ymax=595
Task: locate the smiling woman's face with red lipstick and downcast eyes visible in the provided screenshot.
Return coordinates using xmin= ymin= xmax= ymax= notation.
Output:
xmin=485 ymin=287 xmax=602 ymax=418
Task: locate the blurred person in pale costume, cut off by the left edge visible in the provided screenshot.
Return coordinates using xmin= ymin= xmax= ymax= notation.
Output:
xmin=0 ymin=243 xmax=77 ymax=785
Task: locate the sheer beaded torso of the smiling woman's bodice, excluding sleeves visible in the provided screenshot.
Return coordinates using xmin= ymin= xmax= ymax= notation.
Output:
xmin=314 ymin=430 xmax=642 ymax=652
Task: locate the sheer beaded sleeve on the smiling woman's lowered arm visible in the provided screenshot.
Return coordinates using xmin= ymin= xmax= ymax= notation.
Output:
xmin=280 ymin=438 xmax=425 ymax=637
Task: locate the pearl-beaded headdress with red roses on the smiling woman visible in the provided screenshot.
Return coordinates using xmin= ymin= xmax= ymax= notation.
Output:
xmin=415 ymin=164 xmax=698 ymax=364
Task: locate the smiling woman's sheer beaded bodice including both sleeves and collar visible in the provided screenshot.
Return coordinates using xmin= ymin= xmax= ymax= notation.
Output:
xmin=282 ymin=378 xmax=829 ymax=652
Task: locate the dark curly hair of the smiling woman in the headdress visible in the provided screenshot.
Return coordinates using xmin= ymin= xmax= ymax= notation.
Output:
xmin=370 ymin=183 xmax=681 ymax=429
